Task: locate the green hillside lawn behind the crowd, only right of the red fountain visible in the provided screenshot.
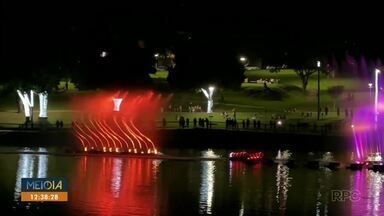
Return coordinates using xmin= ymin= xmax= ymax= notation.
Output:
xmin=149 ymin=69 xmax=369 ymax=111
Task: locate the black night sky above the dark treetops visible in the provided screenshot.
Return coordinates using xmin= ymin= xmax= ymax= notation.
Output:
xmin=1 ymin=0 xmax=384 ymax=66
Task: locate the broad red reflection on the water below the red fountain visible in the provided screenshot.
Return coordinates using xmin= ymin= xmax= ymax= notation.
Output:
xmin=70 ymin=156 xmax=158 ymax=215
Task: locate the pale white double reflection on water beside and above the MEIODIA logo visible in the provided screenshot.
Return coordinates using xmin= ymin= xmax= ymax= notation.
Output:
xmin=14 ymin=148 xmax=48 ymax=201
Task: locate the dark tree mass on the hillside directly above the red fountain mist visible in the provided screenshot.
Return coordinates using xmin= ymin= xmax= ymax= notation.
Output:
xmin=71 ymin=39 xmax=156 ymax=89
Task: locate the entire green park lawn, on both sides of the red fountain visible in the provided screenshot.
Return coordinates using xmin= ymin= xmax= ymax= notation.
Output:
xmin=0 ymin=70 xmax=370 ymax=124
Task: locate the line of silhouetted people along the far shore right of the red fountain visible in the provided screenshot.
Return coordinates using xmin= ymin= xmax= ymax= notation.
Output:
xmin=158 ymin=102 xmax=354 ymax=135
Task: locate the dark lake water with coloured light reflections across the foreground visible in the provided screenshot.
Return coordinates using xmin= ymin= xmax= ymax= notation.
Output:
xmin=0 ymin=148 xmax=384 ymax=216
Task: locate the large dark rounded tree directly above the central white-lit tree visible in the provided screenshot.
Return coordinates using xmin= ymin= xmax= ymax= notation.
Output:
xmin=168 ymin=41 xmax=245 ymax=89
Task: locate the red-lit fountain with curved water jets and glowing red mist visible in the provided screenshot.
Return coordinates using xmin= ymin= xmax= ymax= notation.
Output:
xmin=72 ymin=92 xmax=161 ymax=154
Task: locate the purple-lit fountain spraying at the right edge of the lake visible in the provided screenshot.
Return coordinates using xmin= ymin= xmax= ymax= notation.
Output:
xmin=350 ymin=69 xmax=384 ymax=170
